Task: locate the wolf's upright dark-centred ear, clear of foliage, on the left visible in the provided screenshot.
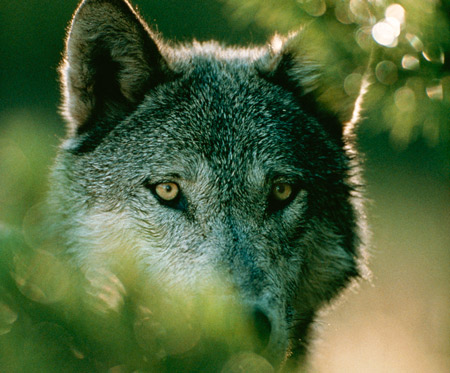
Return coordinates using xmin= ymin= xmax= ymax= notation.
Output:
xmin=60 ymin=0 xmax=169 ymax=135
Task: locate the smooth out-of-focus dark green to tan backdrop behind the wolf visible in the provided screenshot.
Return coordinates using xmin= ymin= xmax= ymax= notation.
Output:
xmin=0 ymin=0 xmax=450 ymax=372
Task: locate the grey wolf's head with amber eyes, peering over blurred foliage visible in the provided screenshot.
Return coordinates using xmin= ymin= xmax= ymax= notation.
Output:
xmin=51 ymin=0 xmax=368 ymax=365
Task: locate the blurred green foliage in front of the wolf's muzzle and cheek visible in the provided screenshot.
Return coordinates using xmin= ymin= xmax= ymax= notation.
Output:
xmin=0 ymin=225 xmax=273 ymax=373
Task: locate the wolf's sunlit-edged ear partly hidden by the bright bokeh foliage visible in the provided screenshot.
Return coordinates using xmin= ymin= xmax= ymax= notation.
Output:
xmin=260 ymin=30 xmax=366 ymax=143
